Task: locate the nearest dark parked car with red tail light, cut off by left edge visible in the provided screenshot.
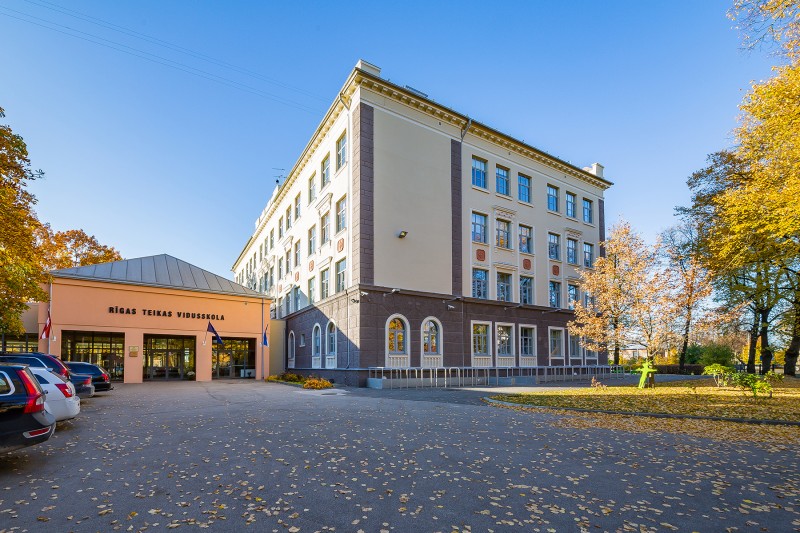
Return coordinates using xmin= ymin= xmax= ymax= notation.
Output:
xmin=0 ymin=362 xmax=56 ymax=452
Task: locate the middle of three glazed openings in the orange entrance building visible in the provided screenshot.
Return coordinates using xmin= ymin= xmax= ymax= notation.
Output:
xmin=142 ymin=335 xmax=196 ymax=380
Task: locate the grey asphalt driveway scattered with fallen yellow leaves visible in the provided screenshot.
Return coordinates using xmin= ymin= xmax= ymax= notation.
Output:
xmin=0 ymin=381 xmax=800 ymax=533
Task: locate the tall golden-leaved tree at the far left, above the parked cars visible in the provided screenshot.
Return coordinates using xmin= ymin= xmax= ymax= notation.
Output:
xmin=0 ymin=108 xmax=47 ymax=334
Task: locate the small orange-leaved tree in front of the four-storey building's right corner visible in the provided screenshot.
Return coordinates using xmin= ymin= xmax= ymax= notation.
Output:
xmin=569 ymin=222 xmax=671 ymax=364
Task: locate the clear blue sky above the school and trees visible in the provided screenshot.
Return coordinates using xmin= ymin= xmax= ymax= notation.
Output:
xmin=0 ymin=0 xmax=777 ymax=277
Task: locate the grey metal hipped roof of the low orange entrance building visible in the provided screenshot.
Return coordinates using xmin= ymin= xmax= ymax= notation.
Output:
xmin=50 ymin=254 xmax=263 ymax=298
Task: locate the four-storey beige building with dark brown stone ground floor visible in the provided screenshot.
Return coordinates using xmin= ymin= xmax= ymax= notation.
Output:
xmin=233 ymin=61 xmax=611 ymax=384
